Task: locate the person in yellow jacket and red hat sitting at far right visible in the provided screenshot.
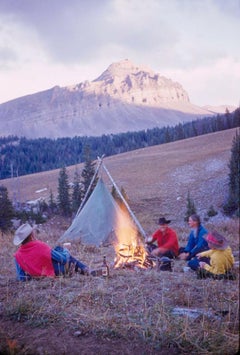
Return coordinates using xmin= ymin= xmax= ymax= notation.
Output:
xmin=197 ymin=231 xmax=235 ymax=279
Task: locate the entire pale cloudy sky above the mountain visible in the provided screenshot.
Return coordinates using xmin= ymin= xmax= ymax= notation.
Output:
xmin=0 ymin=0 xmax=240 ymax=106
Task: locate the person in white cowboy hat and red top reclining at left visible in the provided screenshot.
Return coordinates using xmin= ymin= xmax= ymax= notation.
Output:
xmin=13 ymin=223 xmax=89 ymax=281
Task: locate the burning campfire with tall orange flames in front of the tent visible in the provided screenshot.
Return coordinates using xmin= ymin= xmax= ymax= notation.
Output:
xmin=114 ymin=211 xmax=153 ymax=269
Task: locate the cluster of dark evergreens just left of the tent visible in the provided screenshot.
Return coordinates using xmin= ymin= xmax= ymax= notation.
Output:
xmin=0 ymin=147 xmax=98 ymax=233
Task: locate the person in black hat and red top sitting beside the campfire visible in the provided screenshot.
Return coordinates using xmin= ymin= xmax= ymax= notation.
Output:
xmin=146 ymin=217 xmax=179 ymax=270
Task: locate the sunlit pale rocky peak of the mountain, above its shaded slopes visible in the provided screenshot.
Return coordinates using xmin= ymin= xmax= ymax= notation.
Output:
xmin=91 ymin=59 xmax=189 ymax=107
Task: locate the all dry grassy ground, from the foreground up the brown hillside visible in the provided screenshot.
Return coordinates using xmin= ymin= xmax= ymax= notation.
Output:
xmin=0 ymin=130 xmax=239 ymax=355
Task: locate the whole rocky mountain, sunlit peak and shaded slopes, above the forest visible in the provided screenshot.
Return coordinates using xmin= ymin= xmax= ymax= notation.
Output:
xmin=0 ymin=59 xmax=218 ymax=138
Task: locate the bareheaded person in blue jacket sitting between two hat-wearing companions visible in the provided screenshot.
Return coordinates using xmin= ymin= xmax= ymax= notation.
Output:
xmin=178 ymin=214 xmax=209 ymax=270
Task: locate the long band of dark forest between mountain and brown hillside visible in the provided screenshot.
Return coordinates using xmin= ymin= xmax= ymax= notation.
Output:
xmin=0 ymin=108 xmax=240 ymax=179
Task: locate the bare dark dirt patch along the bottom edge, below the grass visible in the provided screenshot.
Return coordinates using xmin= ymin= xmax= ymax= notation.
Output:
xmin=0 ymin=319 xmax=165 ymax=355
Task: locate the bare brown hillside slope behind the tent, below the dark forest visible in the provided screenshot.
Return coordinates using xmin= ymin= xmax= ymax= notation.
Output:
xmin=1 ymin=129 xmax=236 ymax=229
